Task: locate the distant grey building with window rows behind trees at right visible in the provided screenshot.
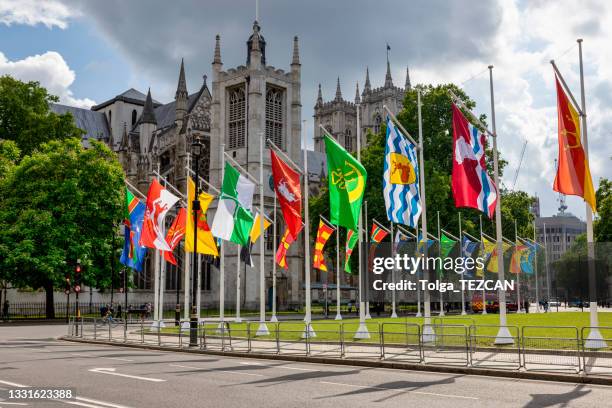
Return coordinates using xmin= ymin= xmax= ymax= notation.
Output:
xmin=536 ymin=212 xmax=586 ymax=262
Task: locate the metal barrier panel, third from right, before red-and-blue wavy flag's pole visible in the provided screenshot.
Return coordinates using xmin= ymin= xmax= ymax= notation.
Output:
xmin=469 ymin=324 xmax=521 ymax=370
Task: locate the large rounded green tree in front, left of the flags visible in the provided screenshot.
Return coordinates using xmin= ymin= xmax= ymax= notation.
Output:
xmin=0 ymin=138 xmax=124 ymax=318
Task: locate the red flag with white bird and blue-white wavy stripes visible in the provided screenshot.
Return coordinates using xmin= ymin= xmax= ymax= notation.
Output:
xmin=452 ymin=104 xmax=497 ymax=218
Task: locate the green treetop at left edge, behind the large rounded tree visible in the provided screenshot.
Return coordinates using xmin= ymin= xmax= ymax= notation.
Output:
xmin=0 ymin=75 xmax=83 ymax=155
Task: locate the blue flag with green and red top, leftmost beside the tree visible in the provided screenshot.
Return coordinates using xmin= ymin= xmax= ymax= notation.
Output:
xmin=119 ymin=188 xmax=147 ymax=272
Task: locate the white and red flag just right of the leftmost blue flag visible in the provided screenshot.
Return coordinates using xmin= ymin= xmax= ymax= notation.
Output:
xmin=140 ymin=179 xmax=179 ymax=251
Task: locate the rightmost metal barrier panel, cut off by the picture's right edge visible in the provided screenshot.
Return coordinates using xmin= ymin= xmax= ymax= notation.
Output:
xmin=580 ymin=326 xmax=612 ymax=375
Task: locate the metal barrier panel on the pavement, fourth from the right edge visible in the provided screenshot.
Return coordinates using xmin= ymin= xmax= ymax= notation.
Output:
xmin=421 ymin=324 xmax=470 ymax=366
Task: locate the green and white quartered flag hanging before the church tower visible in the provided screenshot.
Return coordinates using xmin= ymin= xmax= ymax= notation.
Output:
xmin=212 ymin=163 xmax=255 ymax=246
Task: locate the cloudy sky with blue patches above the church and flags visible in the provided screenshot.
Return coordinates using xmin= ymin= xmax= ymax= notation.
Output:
xmin=0 ymin=0 xmax=612 ymax=218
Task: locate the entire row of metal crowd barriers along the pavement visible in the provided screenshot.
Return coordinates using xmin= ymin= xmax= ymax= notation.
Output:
xmin=67 ymin=316 xmax=612 ymax=375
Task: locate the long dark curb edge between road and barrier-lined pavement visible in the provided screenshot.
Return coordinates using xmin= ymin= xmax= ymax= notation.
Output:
xmin=59 ymin=337 xmax=612 ymax=386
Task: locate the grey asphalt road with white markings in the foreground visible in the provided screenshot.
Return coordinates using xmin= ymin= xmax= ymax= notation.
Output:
xmin=0 ymin=325 xmax=612 ymax=408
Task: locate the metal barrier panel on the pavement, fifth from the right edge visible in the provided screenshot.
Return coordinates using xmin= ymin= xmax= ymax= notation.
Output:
xmin=380 ymin=323 xmax=423 ymax=363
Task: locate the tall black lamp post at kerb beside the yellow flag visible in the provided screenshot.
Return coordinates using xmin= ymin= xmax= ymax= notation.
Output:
xmin=189 ymin=136 xmax=202 ymax=347
